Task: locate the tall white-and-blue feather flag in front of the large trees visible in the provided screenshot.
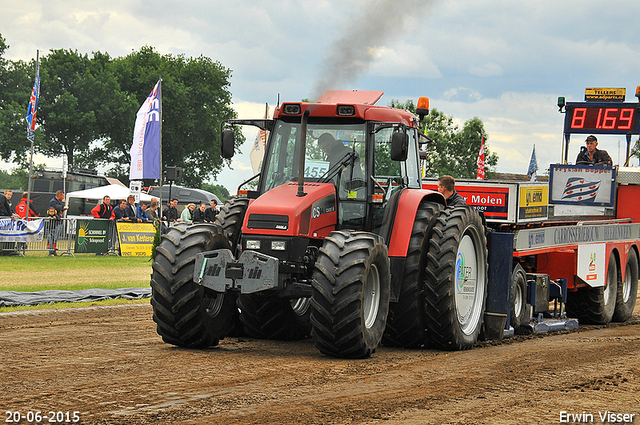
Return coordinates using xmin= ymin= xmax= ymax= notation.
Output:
xmin=129 ymin=81 xmax=162 ymax=180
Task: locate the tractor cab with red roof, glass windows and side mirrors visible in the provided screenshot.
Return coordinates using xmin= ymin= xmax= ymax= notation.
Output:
xmin=222 ymin=91 xmax=426 ymax=234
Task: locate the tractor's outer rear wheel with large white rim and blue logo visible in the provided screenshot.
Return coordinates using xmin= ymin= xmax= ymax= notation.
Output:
xmin=425 ymin=207 xmax=487 ymax=350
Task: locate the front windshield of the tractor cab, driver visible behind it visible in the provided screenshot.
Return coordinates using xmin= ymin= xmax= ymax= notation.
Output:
xmin=262 ymin=121 xmax=366 ymax=192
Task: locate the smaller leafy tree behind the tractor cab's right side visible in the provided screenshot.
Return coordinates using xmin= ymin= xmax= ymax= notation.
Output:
xmin=389 ymin=100 xmax=498 ymax=179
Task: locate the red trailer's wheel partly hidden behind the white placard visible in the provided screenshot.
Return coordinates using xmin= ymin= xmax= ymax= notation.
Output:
xmin=567 ymin=252 xmax=620 ymax=325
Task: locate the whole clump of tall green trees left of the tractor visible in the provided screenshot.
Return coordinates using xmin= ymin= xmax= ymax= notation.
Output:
xmin=0 ymin=40 xmax=244 ymax=187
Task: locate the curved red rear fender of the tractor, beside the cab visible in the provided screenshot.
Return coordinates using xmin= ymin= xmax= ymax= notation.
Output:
xmin=389 ymin=189 xmax=446 ymax=257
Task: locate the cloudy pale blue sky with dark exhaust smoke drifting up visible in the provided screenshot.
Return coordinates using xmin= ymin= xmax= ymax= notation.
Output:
xmin=0 ymin=0 xmax=640 ymax=193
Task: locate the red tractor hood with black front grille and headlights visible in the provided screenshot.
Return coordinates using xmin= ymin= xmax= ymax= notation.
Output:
xmin=242 ymin=182 xmax=337 ymax=239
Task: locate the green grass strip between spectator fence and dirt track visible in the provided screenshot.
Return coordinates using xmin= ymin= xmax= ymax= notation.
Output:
xmin=0 ymin=254 xmax=151 ymax=312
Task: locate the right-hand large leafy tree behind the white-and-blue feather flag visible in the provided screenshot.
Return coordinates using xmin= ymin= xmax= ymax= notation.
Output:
xmin=87 ymin=47 xmax=244 ymax=187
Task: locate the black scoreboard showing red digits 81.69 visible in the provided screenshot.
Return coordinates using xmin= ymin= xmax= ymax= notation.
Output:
xmin=564 ymin=102 xmax=639 ymax=134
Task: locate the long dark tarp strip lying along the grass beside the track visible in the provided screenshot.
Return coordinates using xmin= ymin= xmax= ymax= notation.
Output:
xmin=0 ymin=288 xmax=151 ymax=307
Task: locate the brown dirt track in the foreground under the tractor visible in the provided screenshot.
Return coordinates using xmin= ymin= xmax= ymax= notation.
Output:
xmin=0 ymin=305 xmax=640 ymax=425
